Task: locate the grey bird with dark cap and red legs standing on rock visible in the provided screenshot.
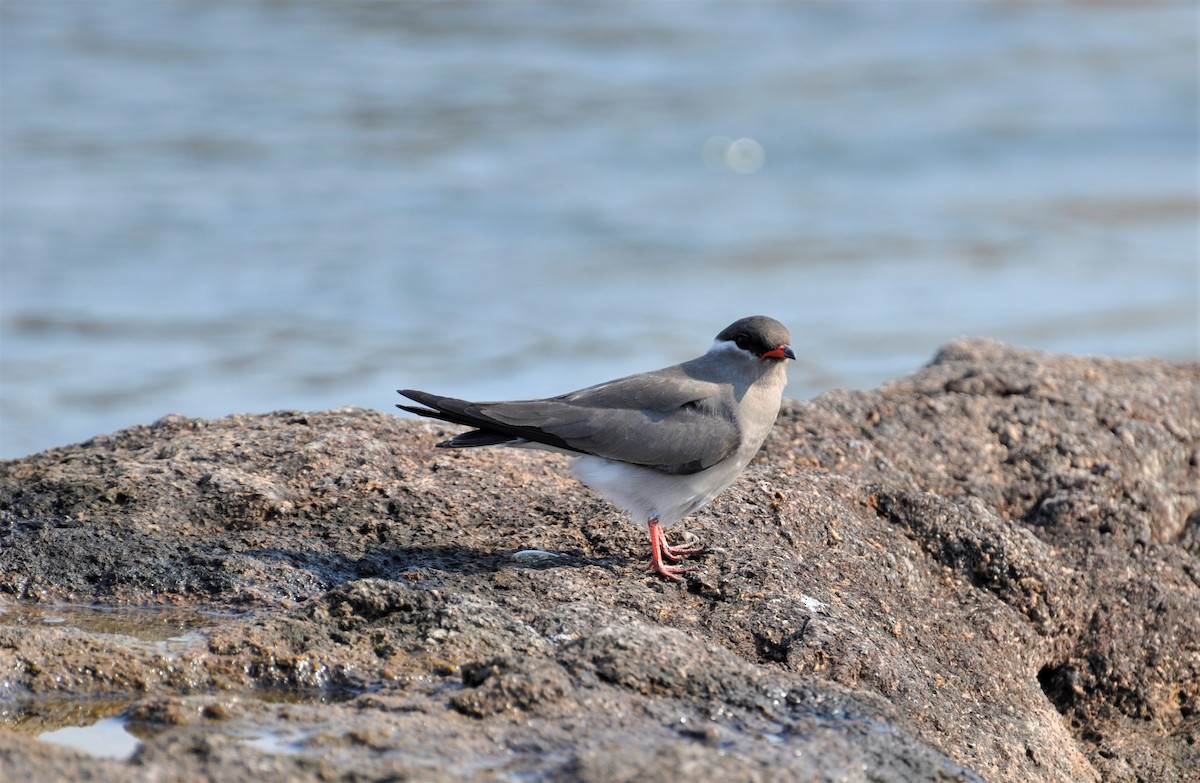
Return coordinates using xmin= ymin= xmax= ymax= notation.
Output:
xmin=396 ymin=316 xmax=796 ymax=581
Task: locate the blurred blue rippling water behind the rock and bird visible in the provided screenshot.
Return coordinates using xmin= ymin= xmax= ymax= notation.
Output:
xmin=0 ymin=0 xmax=1200 ymax=456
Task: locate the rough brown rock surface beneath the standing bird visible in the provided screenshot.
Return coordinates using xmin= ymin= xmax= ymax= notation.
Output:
xmin=0 ymin=341 xmax=1200 ymax=783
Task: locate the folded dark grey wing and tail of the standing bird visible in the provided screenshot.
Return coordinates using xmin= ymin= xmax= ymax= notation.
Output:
xmin=400 ymin=371 xmax=739 ymax=473
